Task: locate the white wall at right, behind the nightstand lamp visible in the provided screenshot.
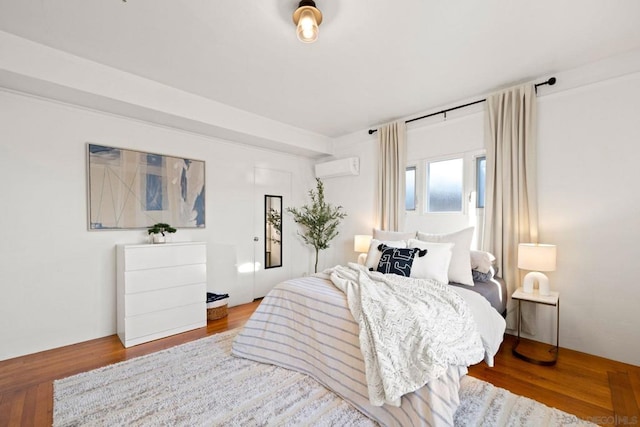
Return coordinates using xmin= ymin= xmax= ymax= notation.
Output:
xmin=538 ymin=73 xmax=640 ymax=365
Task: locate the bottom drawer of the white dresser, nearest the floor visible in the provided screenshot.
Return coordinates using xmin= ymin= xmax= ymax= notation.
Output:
xmin=124 ymin=304 xmax=207 ymax=341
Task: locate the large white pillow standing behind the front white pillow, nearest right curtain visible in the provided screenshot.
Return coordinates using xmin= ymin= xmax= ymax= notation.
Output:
xmin=418 ymin=227 xmax=474 ymax=286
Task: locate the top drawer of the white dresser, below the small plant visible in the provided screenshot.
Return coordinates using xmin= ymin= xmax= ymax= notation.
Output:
xmin=124 ymin=243 xmax=207 ymax=271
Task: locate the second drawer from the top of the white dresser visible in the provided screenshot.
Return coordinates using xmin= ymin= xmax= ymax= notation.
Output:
xmin=124 ymin=264 xmax=207 ymax=294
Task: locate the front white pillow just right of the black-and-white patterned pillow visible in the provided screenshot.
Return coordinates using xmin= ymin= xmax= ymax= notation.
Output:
xmin=407 ymin=239 xmax=454 ymax=284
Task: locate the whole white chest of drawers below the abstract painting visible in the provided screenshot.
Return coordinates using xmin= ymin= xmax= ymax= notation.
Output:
xmin=116 ymin=242 xmax=207 ymax=347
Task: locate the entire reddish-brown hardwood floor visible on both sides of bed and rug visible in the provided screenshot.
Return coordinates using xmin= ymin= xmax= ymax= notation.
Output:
xmin=0 ymin=302 xmax=640 ymax=426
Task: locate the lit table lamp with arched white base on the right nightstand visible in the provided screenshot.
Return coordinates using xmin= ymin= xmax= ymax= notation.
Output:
xmin=518 ymin=243 xmax=556 ymax=295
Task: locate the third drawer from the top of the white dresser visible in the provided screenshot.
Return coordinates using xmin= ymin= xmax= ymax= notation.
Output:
xmin=124 ymin=282 xmax=207 ymax=318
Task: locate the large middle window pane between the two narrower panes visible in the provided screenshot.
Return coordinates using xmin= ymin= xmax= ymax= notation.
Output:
xmin=427 ymin=159 xmax=463 ymax=212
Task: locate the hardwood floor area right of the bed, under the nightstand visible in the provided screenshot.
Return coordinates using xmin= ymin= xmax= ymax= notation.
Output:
xmin=469 ymin=335 xmax=640 ymax=426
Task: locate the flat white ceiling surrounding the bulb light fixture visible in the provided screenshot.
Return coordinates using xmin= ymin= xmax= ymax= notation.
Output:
xmin=0 ymin=0 xmax=640 ymax=137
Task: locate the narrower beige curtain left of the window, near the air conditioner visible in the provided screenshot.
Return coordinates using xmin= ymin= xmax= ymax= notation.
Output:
xmin=376 ymin=121 xmax=407 ymax=231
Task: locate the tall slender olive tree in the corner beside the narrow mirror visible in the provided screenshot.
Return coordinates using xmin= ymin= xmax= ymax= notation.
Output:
xmin=287 ymin=178 xmax=347 ymax=273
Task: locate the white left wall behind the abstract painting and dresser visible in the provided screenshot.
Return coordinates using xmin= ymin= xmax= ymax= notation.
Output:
xmin=0 ymin=91 xmax=314 ymax=360
